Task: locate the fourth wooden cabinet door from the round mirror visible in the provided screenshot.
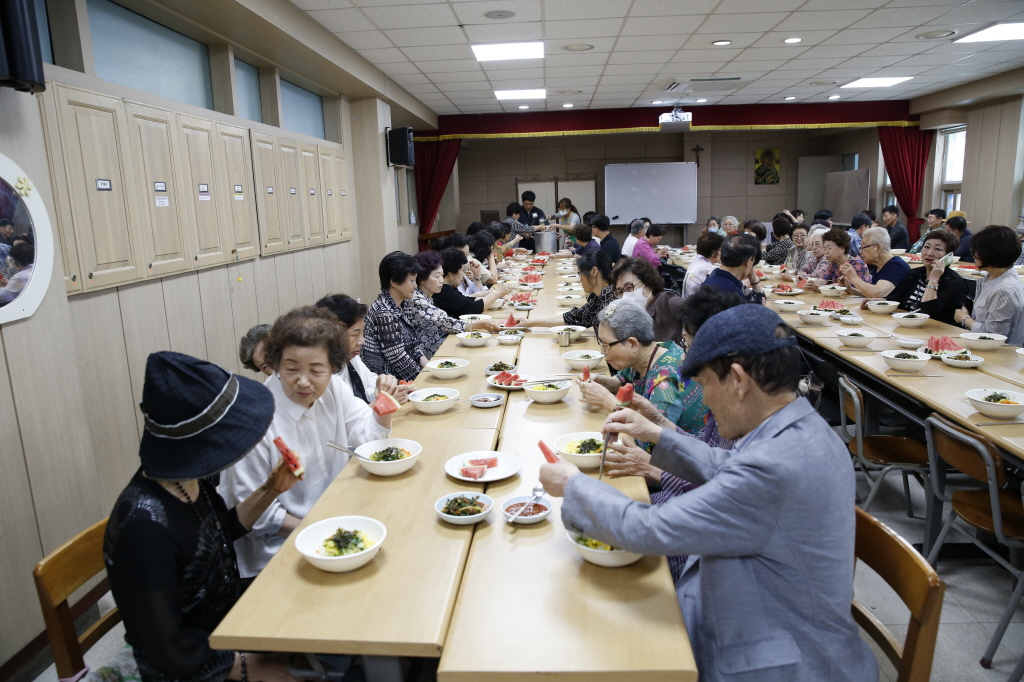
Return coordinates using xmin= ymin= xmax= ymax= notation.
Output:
xmin=213 ymin=123 xmax=259 ymax=261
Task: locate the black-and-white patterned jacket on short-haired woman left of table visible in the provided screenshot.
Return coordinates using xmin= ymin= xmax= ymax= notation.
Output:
xmin=359 ymin=291 xmax=425 ymax=381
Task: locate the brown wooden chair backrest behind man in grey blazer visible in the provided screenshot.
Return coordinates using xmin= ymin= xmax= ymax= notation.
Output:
xmin=853 ymin=509 xmax=946 ymax=682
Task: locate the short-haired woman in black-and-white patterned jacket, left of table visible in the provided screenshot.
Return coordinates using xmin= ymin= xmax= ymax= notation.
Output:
xmin=362 ymin=251 xmax=427 ymax=381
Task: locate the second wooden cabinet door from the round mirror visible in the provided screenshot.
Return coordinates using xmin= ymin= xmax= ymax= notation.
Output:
xmin=126 ymin=102 xmax=193 ymax=276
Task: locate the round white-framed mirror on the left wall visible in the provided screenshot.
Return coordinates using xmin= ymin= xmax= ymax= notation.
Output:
xmin=0 ymin=154 xmax=53 ymax=324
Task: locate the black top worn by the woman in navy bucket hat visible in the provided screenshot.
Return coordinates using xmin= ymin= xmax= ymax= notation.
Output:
xmin=103 ymin=470 xmax=247 ymax=682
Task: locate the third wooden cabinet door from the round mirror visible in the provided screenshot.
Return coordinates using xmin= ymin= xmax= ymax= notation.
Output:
xmin=178 ymin=115 xmax=231 ymax=267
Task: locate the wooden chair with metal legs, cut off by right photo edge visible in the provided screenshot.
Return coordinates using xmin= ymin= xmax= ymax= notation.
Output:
xmin=925 ymin=414 xmax=1024 ymax=668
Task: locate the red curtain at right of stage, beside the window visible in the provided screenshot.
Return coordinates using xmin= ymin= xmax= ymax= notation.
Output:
xmin=879 ymin=126 xmax=935 ymax=243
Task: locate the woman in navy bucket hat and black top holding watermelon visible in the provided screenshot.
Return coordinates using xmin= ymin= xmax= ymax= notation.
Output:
xmin=103 ymin=352 xmax=297 ymax=682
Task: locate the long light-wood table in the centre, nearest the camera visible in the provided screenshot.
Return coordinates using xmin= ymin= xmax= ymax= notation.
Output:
xmin=211 ymin=263 xmax=696 ymax=682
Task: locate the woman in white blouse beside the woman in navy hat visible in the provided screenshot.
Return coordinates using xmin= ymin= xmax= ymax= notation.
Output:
xmin=217 ymin=305 xmax=391 ymax=579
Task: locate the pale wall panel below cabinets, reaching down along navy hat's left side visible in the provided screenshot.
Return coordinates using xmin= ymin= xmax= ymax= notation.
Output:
xmin=118 ymin=282 xmax=171 ymax=438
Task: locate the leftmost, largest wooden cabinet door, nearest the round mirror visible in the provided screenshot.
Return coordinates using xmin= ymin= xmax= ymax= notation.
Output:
xmin=56 ymin=86 xmax=145 ymax=290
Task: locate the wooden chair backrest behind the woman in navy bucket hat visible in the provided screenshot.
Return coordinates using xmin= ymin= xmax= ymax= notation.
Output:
xmin=33 ymin=518 xmax=121 ymax=679
